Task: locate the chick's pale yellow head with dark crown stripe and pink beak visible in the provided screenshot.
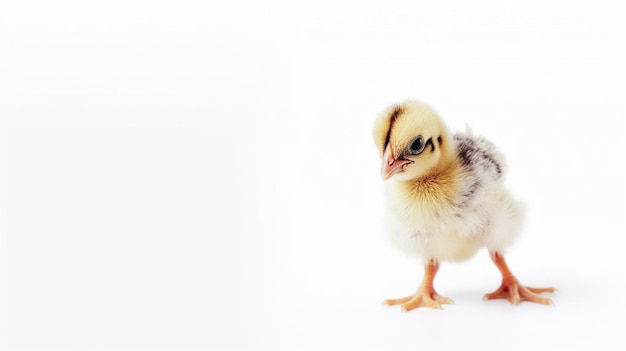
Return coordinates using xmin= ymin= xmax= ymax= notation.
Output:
xmin=374 ymin=101 xmax=453 ymax=180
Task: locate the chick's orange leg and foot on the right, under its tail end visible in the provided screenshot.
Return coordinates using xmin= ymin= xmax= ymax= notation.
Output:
xmin=484 ymin=251 xmax=556 ymax=305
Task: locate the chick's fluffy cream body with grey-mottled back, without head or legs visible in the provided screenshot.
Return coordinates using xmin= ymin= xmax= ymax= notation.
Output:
xmin=385 ymin=133 xmax=521 ymax=260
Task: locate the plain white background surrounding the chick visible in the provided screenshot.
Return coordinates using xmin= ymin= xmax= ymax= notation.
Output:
xmin=0 ymin=0 xmax=626 ymax=350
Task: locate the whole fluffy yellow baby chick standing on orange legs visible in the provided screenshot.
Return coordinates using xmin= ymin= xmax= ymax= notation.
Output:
xmin=374 ymin=101 xmax=555 ymax=311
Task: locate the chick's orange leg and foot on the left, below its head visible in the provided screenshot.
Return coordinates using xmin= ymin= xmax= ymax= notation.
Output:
xmin=383 ymin=259 xmax=454 ymax=312
